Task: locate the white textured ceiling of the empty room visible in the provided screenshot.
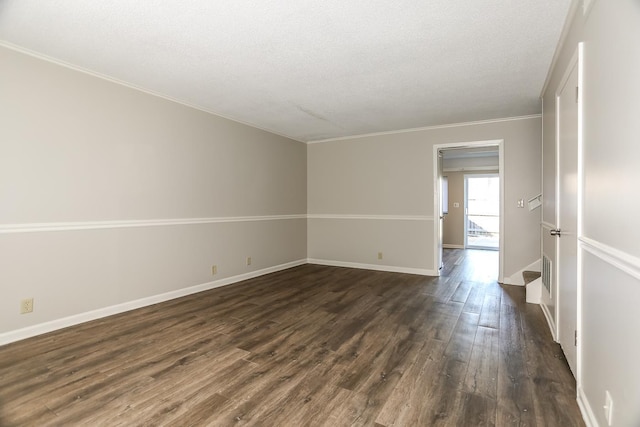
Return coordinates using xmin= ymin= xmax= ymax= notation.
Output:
xmin=0 ymin=0 xmax=571 ymax=141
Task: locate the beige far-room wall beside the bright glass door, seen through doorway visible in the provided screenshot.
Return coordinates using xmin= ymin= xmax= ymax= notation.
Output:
xmin=442 ymin=169 xmax=498 ymax=248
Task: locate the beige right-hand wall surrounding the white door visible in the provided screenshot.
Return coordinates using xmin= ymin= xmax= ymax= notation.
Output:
xmin=543 ymin=0 xmax=640 ymax=426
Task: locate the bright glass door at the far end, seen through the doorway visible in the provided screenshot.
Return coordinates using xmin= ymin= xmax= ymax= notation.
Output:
xmin=464 ymin=173 xmax=500 ymax=250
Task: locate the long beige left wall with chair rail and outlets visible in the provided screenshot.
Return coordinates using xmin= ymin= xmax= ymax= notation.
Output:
xmin=0 ymin=47 xmax=307 ymax=342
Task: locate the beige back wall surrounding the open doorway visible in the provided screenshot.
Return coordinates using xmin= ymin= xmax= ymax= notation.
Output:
xmin=307 ymin=118 xmax=541 ymax=277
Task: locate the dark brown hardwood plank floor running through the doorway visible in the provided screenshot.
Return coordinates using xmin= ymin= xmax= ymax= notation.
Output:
xmin=0 ymin=250 xmax=584 ymax=427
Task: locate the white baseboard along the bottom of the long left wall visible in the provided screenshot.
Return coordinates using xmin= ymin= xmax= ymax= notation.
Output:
xmin=0 ymin=259 xmax=307 ymax=345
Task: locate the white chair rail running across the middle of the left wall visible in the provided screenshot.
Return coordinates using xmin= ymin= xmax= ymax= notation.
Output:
xmin=0 ymin=214 xmax=307 ymax=234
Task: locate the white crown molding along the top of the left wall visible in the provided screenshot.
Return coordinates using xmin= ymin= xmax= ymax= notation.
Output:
xmin=0 ymin=40 xmax=306 ymax=144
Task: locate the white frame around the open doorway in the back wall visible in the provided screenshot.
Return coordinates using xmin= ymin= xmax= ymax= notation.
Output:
xmin=433 ymin=139 xmax=504 ymax=283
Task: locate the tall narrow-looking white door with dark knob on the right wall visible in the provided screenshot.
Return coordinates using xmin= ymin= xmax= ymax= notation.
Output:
xmin=554 ymin=56 xmax=579 ymax=375
